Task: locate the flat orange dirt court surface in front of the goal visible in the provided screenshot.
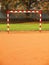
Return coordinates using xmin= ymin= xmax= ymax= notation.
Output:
xmin=0 ymin=32 xmax=49 ymax=65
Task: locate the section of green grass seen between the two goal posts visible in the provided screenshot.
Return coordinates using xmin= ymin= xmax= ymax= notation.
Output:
xmin=10 ymin=23 xmax=38 ymax=31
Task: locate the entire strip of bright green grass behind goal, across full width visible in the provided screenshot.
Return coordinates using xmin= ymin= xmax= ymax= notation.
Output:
xmin=0 ymin=23 xmax=49 ymax=31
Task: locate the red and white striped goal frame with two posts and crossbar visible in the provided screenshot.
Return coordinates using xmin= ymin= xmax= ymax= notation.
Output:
xmin=7 ymin=10 xmax=42 ymax=33
